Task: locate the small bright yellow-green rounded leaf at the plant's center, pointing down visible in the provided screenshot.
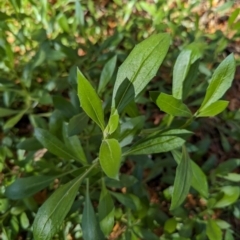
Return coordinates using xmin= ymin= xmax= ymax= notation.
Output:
xmin=99 ymin=139 xmax=121 ymax=179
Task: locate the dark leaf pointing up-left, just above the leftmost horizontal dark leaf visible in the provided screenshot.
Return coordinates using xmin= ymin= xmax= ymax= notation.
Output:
xmin=35 ymin=128 xmax=77 ymax=159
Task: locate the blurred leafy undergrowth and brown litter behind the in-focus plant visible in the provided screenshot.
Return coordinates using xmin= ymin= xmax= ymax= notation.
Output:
xmin=0 ymin=0 xmax=240 ymax=240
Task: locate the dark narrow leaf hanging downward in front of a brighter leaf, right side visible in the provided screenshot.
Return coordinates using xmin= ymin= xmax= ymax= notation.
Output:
xmin=170 ymin=147 xmax=192 ymax=210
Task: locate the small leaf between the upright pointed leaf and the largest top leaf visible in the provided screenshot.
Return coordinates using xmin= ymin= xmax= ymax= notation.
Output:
xmin=98 ymin=56 xmax=117 ymax=93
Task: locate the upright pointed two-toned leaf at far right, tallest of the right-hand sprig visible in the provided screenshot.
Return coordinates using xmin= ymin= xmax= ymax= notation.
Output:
xmin=199 ymin=54 xmax=236 ymax=111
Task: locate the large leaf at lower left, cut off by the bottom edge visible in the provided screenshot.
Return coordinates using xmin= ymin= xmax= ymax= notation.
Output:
xmin=33 ymin=175 xmax=84 ymax=240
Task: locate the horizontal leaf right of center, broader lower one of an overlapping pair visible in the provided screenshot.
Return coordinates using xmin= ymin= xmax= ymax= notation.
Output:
xmin=124 ymin=136 xmax=185 ymax=155
